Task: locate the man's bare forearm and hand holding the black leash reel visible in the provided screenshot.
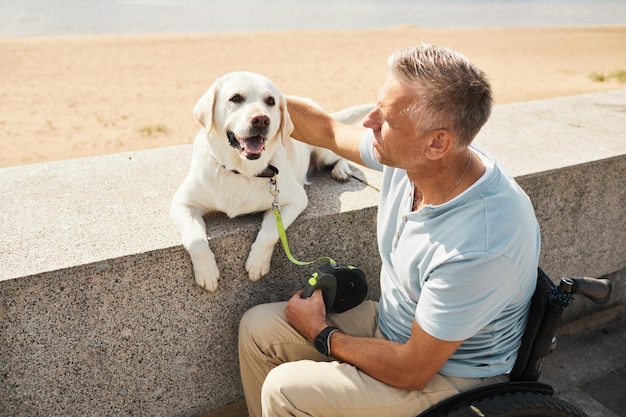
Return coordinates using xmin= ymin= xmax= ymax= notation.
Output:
xmin=285 ymin=290 xmax=463 ymax=391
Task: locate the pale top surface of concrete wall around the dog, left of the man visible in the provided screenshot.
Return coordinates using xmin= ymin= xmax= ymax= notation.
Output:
xmin=0 ymin=145 xmax=379 ymax=280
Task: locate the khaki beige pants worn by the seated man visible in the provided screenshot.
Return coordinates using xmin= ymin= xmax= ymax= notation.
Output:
xmin=239 ymin=301 xmax=508 ymax=417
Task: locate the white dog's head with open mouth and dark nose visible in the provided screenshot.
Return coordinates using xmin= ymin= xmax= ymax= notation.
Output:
xmin=194 ymin=72 xmax=293 ymax=160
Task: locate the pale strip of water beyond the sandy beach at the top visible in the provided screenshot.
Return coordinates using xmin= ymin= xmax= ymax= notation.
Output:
xmin=0 ymin=0 xmax=626 ymax=36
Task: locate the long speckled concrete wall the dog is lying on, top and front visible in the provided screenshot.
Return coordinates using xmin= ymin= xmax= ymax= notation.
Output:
xmin=0 ymin=90 xmax=626 ymax=416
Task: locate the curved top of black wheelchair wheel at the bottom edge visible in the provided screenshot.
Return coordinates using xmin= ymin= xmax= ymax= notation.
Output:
xmin=448 ymin=393 xmax=588 ymax=417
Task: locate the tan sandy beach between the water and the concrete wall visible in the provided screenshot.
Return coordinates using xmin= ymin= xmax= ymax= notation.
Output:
xmin=0 ymin=26 xmax=626 ymax=167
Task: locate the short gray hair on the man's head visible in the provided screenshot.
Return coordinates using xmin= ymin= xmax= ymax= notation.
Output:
xmin=388 ymin=44 xmax=493 ymax=146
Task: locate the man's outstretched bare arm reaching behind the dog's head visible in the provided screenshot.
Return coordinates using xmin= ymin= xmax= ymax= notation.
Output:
xmin=287 ymin=97 xmax=365 ymax=165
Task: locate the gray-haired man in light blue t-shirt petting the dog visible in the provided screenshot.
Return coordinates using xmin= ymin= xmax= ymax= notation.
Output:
xmin=239 ymin=45 xmax=540 ymax=417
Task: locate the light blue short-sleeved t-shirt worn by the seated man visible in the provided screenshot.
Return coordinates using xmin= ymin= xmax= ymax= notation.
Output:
xmin=361 ymin=130 xmax=540 ymax=378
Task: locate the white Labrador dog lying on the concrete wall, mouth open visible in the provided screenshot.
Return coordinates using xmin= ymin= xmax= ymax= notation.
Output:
xmin=170 ymin=72 xmax=371 ymax=291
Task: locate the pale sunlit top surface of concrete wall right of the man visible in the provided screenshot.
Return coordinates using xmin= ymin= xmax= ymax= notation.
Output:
xmin=476 ymin=90 xmax=626 ymax=178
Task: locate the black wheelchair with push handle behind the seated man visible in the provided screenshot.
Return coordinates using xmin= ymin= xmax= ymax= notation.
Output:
xmin=417 ymin=268 xmax=612 ymax=417
